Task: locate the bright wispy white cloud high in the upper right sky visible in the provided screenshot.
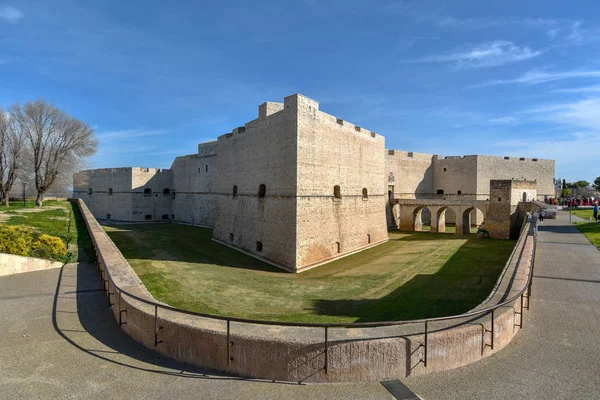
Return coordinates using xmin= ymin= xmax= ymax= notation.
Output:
xmin=408 ymin=40 xmax=542 ymax=69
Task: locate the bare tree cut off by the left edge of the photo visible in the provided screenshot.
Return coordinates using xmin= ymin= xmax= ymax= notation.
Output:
xmin=0 ymin=108 xmax=24 ymax=206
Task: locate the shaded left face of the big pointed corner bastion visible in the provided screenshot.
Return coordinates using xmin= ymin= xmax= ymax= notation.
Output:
xmin=213 ymin=99 xmax=297 ymax=270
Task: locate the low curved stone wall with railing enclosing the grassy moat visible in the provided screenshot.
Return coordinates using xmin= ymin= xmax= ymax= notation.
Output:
xmin=76 ymin=199 xmax=533 ymax=382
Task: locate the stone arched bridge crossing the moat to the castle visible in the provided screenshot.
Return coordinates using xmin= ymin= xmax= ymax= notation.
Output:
xmin=390 ymin=198 xmax=489 ymax=235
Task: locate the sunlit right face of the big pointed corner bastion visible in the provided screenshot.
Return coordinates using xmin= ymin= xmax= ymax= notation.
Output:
xmin=296 ymin=96 xmax=388 ymax=269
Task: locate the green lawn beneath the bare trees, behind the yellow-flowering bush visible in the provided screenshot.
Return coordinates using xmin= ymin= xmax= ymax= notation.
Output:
xmin=0 ymin=200 xmax=95 ymax=262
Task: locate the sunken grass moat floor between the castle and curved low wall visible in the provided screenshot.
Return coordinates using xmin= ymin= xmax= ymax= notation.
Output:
xmin=104 ymin=224 xmax=515 ymax=322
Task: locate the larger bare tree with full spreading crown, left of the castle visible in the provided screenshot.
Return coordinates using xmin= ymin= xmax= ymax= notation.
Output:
xmin=11 ymin=100 xmax=98 ymax=206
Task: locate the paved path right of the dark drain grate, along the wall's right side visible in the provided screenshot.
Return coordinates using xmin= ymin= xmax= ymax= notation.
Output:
xmin=406 ymin=211 xmax=600 ymax=399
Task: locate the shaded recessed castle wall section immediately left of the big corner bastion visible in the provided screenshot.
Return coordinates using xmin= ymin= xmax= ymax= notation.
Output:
xmin=171 ymin=141 xmax=218 ymax=227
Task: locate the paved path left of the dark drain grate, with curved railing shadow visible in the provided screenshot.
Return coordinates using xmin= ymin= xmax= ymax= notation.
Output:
xmin=0 ymin=263 xmax=391 ymax=400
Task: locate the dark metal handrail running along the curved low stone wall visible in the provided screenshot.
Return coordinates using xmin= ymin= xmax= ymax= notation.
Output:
xmin=78 ymin=198 xmax=537 ymax=373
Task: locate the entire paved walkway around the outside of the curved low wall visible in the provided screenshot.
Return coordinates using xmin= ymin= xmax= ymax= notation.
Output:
xmin=0 ymin=212 xmax=600 ymax=400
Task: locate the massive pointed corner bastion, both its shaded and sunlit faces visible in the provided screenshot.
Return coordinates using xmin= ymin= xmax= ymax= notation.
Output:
xmin=213 ymin=94 xmax=387 ymax=272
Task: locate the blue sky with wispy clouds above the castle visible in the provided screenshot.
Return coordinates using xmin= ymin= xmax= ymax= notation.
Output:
xmin=0 ymin=0 xmax=600 ymax=181
